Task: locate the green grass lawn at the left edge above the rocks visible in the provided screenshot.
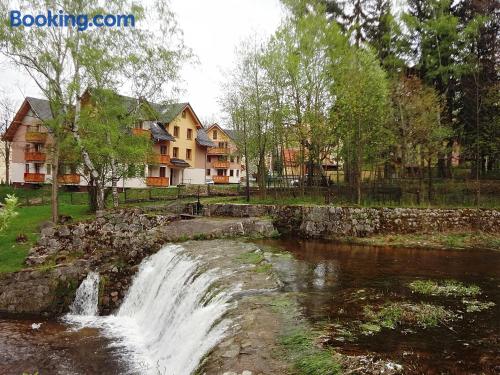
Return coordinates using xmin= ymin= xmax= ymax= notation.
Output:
xmin=0 ymin=204 xmax=91 ymax=273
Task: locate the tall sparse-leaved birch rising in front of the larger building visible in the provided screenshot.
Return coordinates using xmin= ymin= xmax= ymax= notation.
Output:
xmin=0 ymin=0 xmax=190 ymax=217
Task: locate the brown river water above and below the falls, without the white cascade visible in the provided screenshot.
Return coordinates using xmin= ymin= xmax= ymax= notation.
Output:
xmin=0 ymin=239 xmax=500 ymax=375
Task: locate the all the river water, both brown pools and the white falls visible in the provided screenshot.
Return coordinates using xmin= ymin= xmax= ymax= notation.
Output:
xmin=0 ymin=240 xmax=500 ymax=375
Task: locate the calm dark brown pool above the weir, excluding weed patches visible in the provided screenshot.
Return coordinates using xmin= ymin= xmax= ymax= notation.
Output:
xmin=259 ymin=239 xmax=500 ymax=374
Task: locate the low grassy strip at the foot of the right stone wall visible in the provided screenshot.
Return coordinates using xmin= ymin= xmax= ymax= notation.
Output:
xmin=336 ymin=232 xmax=500 ymax=251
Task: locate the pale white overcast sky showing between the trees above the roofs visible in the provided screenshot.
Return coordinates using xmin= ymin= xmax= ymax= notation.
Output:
xmin=0 ymin=0 xmax=284 ymax=125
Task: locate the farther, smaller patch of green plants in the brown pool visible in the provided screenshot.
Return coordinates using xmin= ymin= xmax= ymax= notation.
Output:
xmin=408 ymin=280 xmax=481 ymax=297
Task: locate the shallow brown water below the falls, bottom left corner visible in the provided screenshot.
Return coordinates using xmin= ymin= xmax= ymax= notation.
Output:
xmin=0 ymin=317 xmax=125 ymax=375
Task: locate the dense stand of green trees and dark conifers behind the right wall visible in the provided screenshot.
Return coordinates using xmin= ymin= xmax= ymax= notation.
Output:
xmin=220 ymin=0 xmax=500 ymax=204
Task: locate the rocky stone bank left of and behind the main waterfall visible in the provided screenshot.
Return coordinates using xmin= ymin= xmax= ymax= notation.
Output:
xmin=0 ymin=209 xmax=274 ymax=316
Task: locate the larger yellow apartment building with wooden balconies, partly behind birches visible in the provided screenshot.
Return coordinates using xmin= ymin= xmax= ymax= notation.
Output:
xmin=4 ymin=91 xmax=216 ymax=188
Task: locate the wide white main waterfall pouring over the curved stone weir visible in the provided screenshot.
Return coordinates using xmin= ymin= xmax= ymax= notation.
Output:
xmin=65 ymin=245 xmax=237 ymax=375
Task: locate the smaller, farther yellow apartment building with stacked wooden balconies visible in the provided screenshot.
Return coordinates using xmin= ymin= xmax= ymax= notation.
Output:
xmin=206 ymin=124 xmax=245 ymax=184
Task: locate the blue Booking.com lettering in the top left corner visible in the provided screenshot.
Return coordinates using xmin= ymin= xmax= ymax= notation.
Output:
xmin=9 ymin=10 xmax=135 ymax=31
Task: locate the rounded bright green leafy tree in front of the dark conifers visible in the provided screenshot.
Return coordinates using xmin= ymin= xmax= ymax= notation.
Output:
xmin=331 ymin=48 xmax=393 ymax=204
